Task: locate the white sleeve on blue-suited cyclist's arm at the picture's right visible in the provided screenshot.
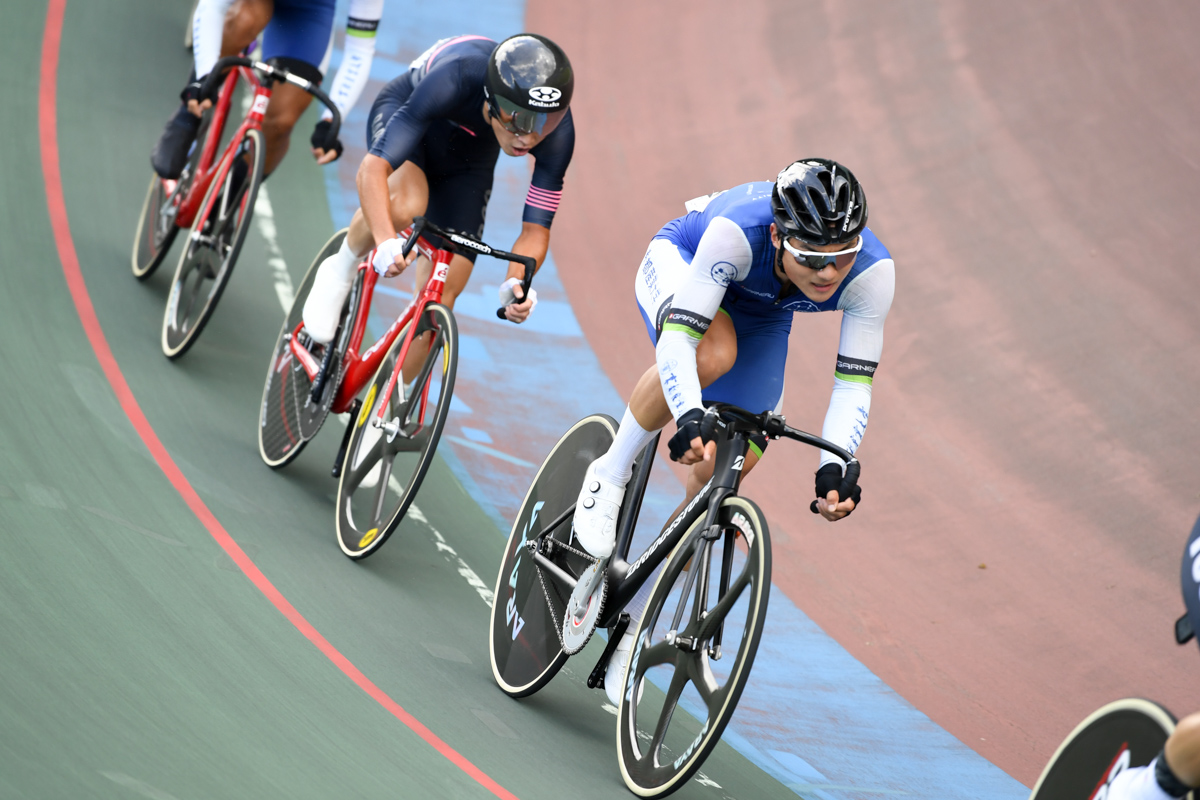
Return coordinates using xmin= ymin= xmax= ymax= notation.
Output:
xmin=821 ymin=259 xmax=895 ymax=467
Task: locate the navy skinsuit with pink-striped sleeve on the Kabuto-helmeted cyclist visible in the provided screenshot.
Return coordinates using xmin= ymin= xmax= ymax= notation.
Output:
xmin=367 ymin=36 xmax=575 ymax=261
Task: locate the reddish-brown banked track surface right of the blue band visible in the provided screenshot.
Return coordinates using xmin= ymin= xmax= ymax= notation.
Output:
xmin=540 ymin=0 xmax=1200 ymax=784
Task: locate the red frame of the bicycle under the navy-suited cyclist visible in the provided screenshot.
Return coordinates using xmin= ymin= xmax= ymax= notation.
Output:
xmin=289 ymin=228 xmax=454 ymax=421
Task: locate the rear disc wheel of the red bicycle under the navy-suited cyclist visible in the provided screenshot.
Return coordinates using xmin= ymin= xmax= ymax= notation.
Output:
xmin=258 ymin=228 xmax=352 ymax=469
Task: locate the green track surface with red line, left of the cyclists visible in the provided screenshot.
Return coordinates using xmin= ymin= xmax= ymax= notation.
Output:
xmin=0 ymin=0 xmax=794 ymax=800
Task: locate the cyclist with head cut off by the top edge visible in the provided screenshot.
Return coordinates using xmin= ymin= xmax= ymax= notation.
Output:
xmin=150 ymin=0 xmax=384 ymax=184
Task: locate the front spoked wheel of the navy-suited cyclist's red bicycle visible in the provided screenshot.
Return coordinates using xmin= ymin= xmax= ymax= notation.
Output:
xmin=336 ymin=302 xmax=458 ymax=559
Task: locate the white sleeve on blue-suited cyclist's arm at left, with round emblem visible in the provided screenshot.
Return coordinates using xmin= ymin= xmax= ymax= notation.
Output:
xmin=654 ymin=217 xmax=751 ymax=420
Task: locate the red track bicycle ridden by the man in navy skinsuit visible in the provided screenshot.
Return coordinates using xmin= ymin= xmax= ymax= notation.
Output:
xmin=258 ymin=217 xmax=535 ymax=559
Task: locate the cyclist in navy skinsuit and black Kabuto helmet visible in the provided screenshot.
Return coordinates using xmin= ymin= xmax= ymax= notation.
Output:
xmin=304 ymin=34 xmax=575 ymax=340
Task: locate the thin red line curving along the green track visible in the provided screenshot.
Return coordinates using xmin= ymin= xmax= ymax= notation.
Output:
xmin=37 ymin=0 xmax=516 ymax=800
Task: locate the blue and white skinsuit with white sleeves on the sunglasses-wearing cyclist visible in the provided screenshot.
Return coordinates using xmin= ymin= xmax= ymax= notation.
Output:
xmin=636 ymin=181 xmax=895 ymax=464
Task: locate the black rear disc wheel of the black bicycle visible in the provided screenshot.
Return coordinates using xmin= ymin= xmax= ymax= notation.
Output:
xmin=487 ymin=414 xmax=617 ymax=697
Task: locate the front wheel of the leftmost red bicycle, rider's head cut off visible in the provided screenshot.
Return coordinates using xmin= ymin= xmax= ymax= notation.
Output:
xmin=162 ymin=128 xmax=264 ymax=359
